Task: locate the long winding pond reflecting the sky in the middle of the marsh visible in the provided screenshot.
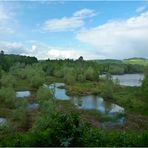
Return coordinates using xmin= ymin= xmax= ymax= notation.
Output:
xmin=49 ymin=83 xmax=125 ymax=125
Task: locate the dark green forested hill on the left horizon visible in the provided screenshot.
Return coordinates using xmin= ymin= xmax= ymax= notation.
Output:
xmin=0 ymin=51 xmax=38 ymax=71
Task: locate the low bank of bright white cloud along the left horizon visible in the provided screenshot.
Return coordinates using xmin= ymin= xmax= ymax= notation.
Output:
xmin=0 ymin=40 xmax=106 ymax=59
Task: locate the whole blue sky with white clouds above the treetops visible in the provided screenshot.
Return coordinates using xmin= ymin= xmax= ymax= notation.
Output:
xmin=0 ymin=0 xmax=148 ymax=60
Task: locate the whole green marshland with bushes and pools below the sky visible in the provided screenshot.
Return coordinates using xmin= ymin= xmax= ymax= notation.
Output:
xmin=0 ymin=53 xmax=148 ymax=147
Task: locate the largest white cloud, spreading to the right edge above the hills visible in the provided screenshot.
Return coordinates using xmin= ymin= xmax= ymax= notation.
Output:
xmin=76 ymin=12 xmax=148 ymax=58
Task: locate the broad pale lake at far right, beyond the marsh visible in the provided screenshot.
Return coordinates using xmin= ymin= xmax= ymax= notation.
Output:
xmin=101 ymin=74 xmax=144 ymax=86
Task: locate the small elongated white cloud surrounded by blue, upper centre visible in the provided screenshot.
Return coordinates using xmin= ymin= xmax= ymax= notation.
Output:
xmin=42 ymin=8 xmax=95 ymax=32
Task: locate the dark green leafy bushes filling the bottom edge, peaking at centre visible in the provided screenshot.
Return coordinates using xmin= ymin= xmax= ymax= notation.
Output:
xmin=0 ymin=113 xmax=148 ymax=147
